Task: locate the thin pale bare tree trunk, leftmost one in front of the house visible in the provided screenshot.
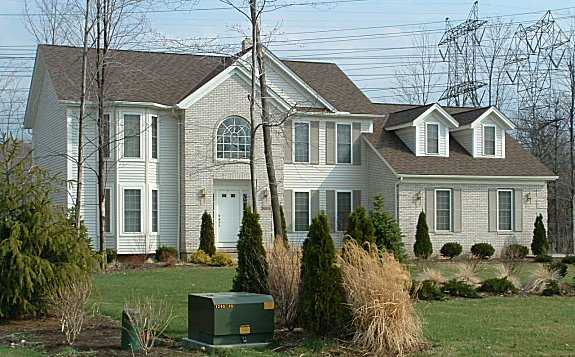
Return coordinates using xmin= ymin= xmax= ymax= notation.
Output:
xmin=74 ymin=0 xmax=91 ymax=231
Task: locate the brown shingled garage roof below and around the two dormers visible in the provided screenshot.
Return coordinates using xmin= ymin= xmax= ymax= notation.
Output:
xmin=364 ymin=119 xmax=555 ymax=177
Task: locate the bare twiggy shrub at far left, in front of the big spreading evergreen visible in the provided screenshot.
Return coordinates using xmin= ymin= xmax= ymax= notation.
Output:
xmin=52 ymin=279 xmax=92 ymax=345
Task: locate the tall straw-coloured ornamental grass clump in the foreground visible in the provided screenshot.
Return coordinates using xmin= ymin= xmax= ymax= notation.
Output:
xmin=338 ymin=240 xmax=426 ymax=356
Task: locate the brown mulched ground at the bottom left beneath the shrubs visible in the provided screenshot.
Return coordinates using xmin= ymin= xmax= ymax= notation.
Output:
xmin=0 ymin=316 xmax=196 ymax=357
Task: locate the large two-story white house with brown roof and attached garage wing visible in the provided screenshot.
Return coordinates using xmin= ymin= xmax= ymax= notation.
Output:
xmin=25 ymin=45 xmax=556 ymax=255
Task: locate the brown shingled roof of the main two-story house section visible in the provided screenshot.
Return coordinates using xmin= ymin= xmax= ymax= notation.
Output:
xmin=38 ymin=45 xmax=372 ymax=114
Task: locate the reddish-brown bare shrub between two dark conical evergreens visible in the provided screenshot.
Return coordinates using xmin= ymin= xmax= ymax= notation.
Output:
xmin=267 ymin=237 xmax=302 ymax=331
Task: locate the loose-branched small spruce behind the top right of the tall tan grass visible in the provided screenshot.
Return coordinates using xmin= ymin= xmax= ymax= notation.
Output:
xmin=369 ymin=194 xmax=407 ymax=263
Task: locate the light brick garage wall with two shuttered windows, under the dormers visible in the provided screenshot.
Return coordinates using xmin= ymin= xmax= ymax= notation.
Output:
xmin=399 ymin=184 xmax=547 ymax=256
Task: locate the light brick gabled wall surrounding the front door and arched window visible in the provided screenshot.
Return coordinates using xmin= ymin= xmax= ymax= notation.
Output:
xmin=179 ymin=75 xmax=283 ymax=254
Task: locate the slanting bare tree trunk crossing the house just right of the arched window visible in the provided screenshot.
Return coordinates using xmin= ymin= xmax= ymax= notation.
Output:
xmin=250 ymin=0 xmax=283 ymax=237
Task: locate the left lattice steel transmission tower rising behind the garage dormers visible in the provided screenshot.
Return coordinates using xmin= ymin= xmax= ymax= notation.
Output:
xmin=438 ymin=1 xmax=487 ymax=107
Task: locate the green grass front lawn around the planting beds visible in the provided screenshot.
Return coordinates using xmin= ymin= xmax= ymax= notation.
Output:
xmin=92 ymin=263 xmax=575 ymax=356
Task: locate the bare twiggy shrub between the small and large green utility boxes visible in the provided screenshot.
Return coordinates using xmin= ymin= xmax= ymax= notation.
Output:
xmin=124 ymin=297 xmax=175 ymax=355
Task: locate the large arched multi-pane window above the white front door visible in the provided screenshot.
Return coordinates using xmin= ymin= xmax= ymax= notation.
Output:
xmin=217 ymin=117 xmax=252 ymax=159
